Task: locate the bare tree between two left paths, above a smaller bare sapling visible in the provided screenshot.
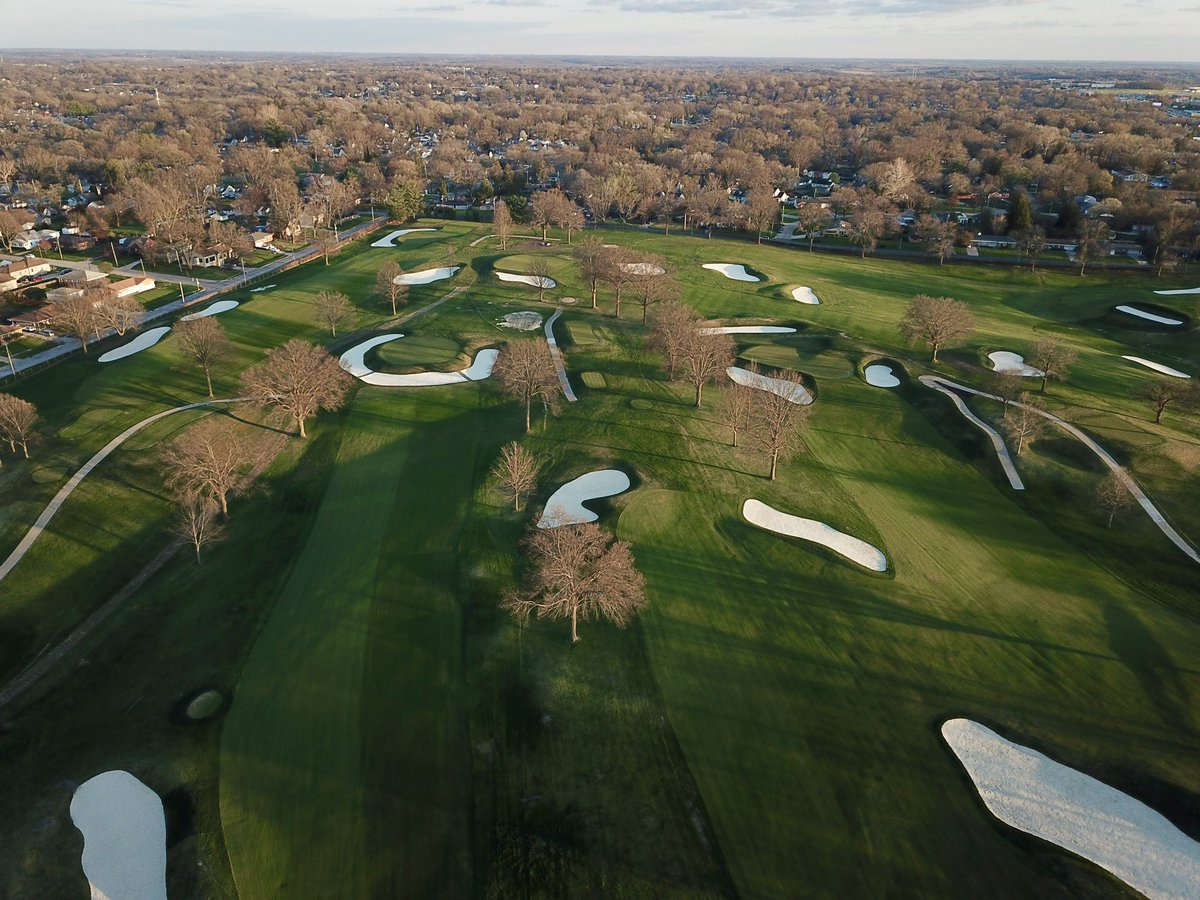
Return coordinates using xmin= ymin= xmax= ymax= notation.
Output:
xmin=162 ymin=419 xmax=254 ymax=516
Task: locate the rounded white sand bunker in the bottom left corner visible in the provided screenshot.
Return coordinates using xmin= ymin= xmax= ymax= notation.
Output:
xmin=71 ymin=769 xmax=167 ymax=900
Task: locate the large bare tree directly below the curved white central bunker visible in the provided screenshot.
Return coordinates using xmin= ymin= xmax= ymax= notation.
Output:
xmin=503 ymin=523 xmax=646 ymax=643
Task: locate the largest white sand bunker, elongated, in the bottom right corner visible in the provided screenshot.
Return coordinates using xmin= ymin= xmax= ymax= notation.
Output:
xmin=942 ymin=719 xmax=1200 ymax=900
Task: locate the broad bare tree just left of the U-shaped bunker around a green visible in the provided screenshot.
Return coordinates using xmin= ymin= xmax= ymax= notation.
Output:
xmin=241 ymin=338 xmax=354 ymax=438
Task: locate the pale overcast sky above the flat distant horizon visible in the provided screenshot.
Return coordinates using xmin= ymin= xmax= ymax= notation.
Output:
xmin=16 ymin=0 xmax=1200 ymax=61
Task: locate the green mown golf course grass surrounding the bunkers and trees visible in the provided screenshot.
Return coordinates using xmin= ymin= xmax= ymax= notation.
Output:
xmin=0 ymin=221 xmax=1200 ymax=898
